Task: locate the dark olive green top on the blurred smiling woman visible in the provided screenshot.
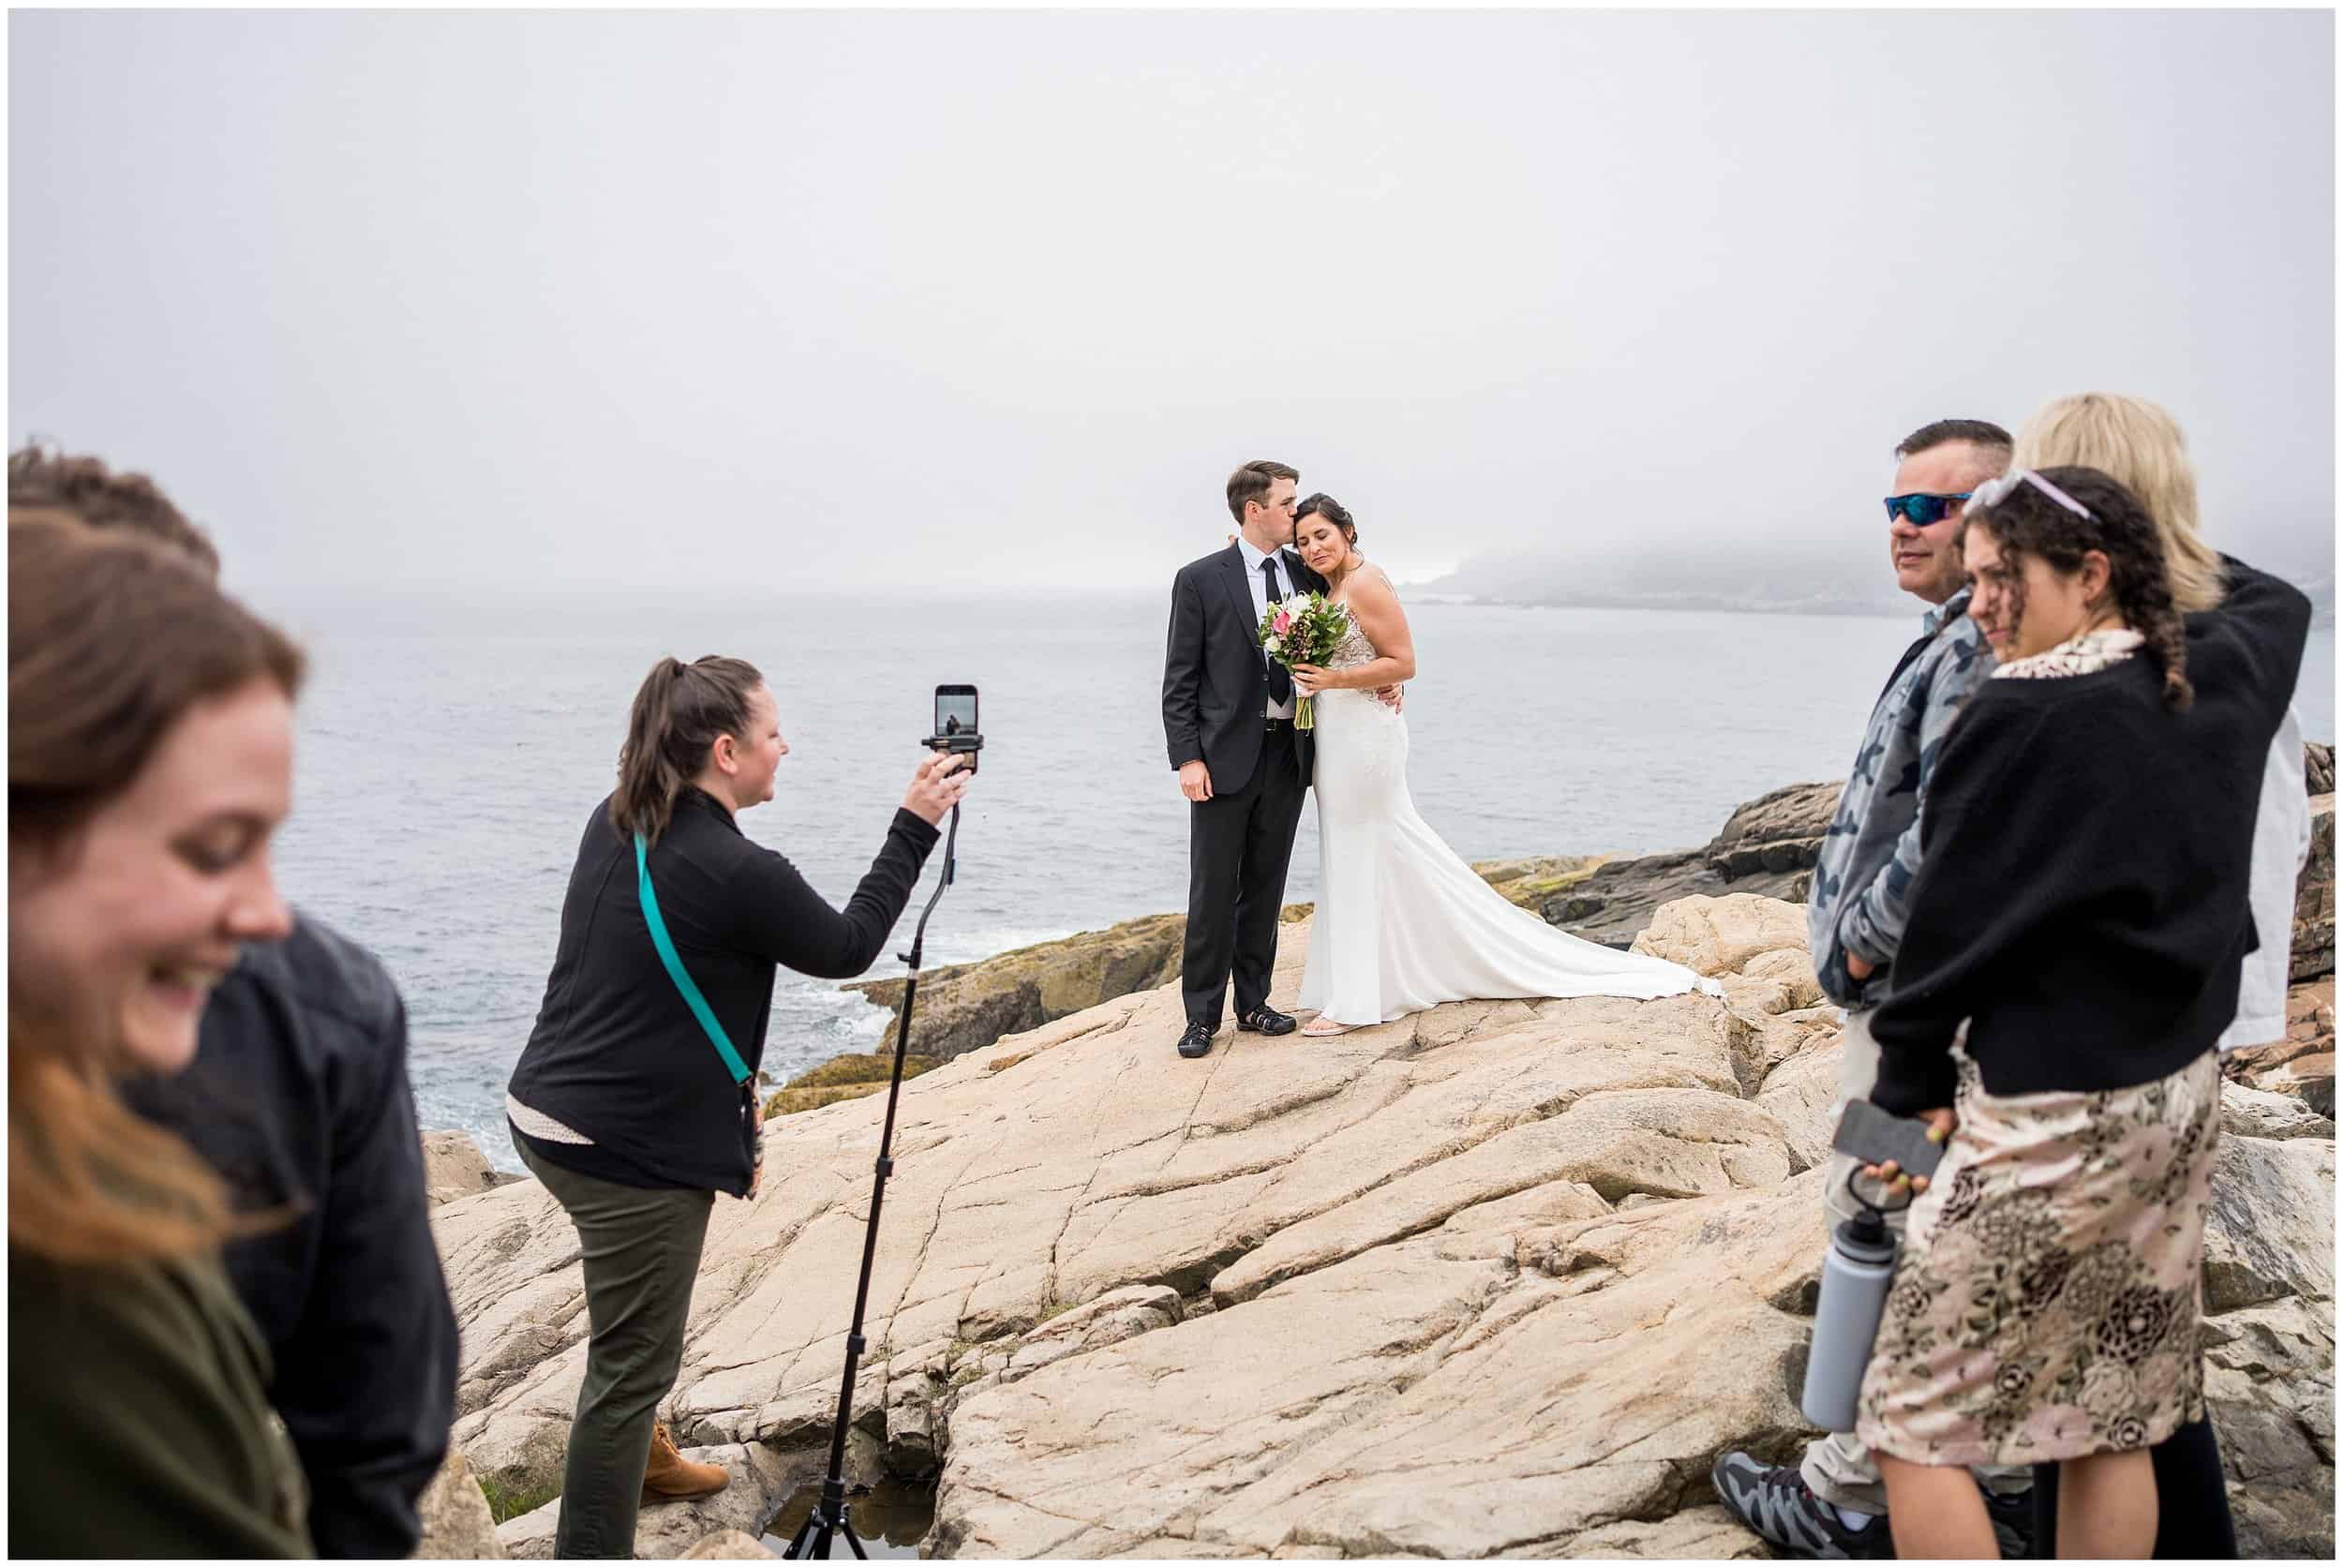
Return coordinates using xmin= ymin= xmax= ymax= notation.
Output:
xmin=7 ymin=1247 xmax=309 ymax=1559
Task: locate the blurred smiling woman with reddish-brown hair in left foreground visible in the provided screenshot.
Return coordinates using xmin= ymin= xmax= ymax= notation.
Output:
xmin=7 ymin=509 xmax=309 ymax=1556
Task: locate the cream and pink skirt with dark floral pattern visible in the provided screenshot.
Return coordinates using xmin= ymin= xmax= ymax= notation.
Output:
xmin=1856 ymin=1045 xmax=2221 ymax=1465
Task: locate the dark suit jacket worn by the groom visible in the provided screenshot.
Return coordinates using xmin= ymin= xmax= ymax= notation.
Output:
xmin=1165 ymin=544 xmax=1326 ymax=795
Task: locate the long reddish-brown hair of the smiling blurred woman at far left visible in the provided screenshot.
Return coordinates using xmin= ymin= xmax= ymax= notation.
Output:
xmin=7 ymin=506 xmax=303 ymax=1263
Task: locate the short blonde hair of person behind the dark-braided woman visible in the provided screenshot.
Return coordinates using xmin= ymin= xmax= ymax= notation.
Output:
xmin=2010 ymin=392 xmax=2224 ymax=614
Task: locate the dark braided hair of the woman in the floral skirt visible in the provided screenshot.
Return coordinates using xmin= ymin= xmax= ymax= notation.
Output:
xmin=1962 ymin=467 xmax=2196 ymax=712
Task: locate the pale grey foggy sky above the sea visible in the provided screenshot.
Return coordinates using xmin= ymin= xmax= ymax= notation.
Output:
xmin=7 ymin=12 xmax=2336 ymax=590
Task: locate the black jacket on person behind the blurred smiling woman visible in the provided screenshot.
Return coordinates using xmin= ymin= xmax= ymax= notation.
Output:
xmin=125 ymin=917 xmax=457 ymax=1556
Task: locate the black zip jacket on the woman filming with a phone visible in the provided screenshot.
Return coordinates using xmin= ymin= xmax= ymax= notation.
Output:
xmin=511 ymin=790 xmax=937 ymax=1195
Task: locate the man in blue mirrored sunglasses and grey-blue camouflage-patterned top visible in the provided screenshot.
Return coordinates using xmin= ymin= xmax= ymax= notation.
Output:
xmin=1713 ymin=420 xmax=2032 ymax=1559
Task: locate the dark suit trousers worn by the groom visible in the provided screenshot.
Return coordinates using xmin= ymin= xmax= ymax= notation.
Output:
xmin=1179 ymin=724 xmax=1307 ymax=1029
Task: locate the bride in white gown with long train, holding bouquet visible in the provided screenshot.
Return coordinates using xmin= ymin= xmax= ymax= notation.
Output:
xmin=1293 ymin=495 xmax=1718 ymax=1036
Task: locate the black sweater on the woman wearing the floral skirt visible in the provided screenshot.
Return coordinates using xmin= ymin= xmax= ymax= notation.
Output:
xmin=1873 ymin=562 xmax=2310 ymax=1115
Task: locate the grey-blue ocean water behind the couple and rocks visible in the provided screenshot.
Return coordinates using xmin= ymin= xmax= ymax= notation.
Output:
xmin=253 ymin=595 xmax=2334 ymax=1170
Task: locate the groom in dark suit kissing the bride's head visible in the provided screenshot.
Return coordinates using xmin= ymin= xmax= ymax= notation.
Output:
xmin=1165 ymin=462 xmax=1326 ymax=1057
